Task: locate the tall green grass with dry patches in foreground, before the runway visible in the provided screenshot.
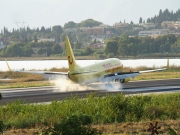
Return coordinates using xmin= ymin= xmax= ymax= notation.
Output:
xmin=0 ymin=93 xmax=180 ymax=134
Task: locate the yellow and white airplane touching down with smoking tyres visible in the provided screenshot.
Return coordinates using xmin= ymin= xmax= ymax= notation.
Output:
xmin=6 ymin=36 xmax=166 ymax=84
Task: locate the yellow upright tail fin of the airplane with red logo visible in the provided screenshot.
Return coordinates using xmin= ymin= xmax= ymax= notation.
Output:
xmin=65 ymin=36 xmax=80 ymax=71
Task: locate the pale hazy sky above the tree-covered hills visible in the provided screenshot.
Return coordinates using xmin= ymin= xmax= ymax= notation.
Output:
xmin=0 ymin=0 xmax=180 ymax=30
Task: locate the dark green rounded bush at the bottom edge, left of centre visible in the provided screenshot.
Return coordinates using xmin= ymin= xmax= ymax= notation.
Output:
xmin=42 ymin=115 xmax=102 ymax=135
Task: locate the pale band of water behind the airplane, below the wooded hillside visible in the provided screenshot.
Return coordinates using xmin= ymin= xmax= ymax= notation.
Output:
xmin=0 ymin=59 xmax=180 ymax=71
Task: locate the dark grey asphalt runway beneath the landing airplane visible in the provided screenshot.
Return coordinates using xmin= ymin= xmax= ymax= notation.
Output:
xmin=0 ymin=79 xmax=180 ymax=104
